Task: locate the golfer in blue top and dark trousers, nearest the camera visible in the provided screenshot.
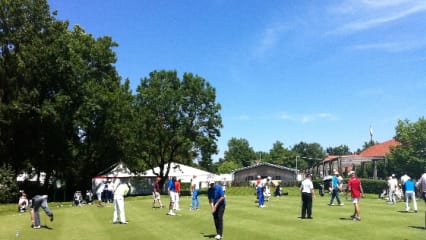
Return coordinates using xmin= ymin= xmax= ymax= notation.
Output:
xmin=207 ymin=180 xmax=226 ymax=239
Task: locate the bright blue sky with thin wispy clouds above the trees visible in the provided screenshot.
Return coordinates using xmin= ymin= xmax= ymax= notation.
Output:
xmin=48 ymin=0 xmax=426 ymax=159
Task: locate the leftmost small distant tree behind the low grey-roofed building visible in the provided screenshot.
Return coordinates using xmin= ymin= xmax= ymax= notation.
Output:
xmin=224 ymin=138 xmax=258 ymax=167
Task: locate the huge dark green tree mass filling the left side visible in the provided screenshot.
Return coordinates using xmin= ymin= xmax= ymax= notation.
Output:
xmin=0 ymin=0 xmax=133 ymax=191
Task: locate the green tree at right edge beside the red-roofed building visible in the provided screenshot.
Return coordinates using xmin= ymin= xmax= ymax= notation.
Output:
xmin=388 ymin=117 xmax=426 ymax=178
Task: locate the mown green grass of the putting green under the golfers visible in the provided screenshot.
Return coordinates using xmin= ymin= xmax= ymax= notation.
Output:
xmin=0 ymin=189 xmax=426 ymax=240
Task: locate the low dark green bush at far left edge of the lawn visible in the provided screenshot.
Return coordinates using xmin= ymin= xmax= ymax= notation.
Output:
xmin=0 ymin=165 xmax=18 ymax=203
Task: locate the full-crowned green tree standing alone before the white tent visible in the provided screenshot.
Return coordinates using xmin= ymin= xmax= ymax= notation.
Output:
xmin=136 ymin=71 xmax=222 ymax=187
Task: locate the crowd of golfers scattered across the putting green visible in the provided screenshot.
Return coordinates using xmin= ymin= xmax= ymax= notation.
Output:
xmin=18 ymin=171 xmax=426 ymax=239
